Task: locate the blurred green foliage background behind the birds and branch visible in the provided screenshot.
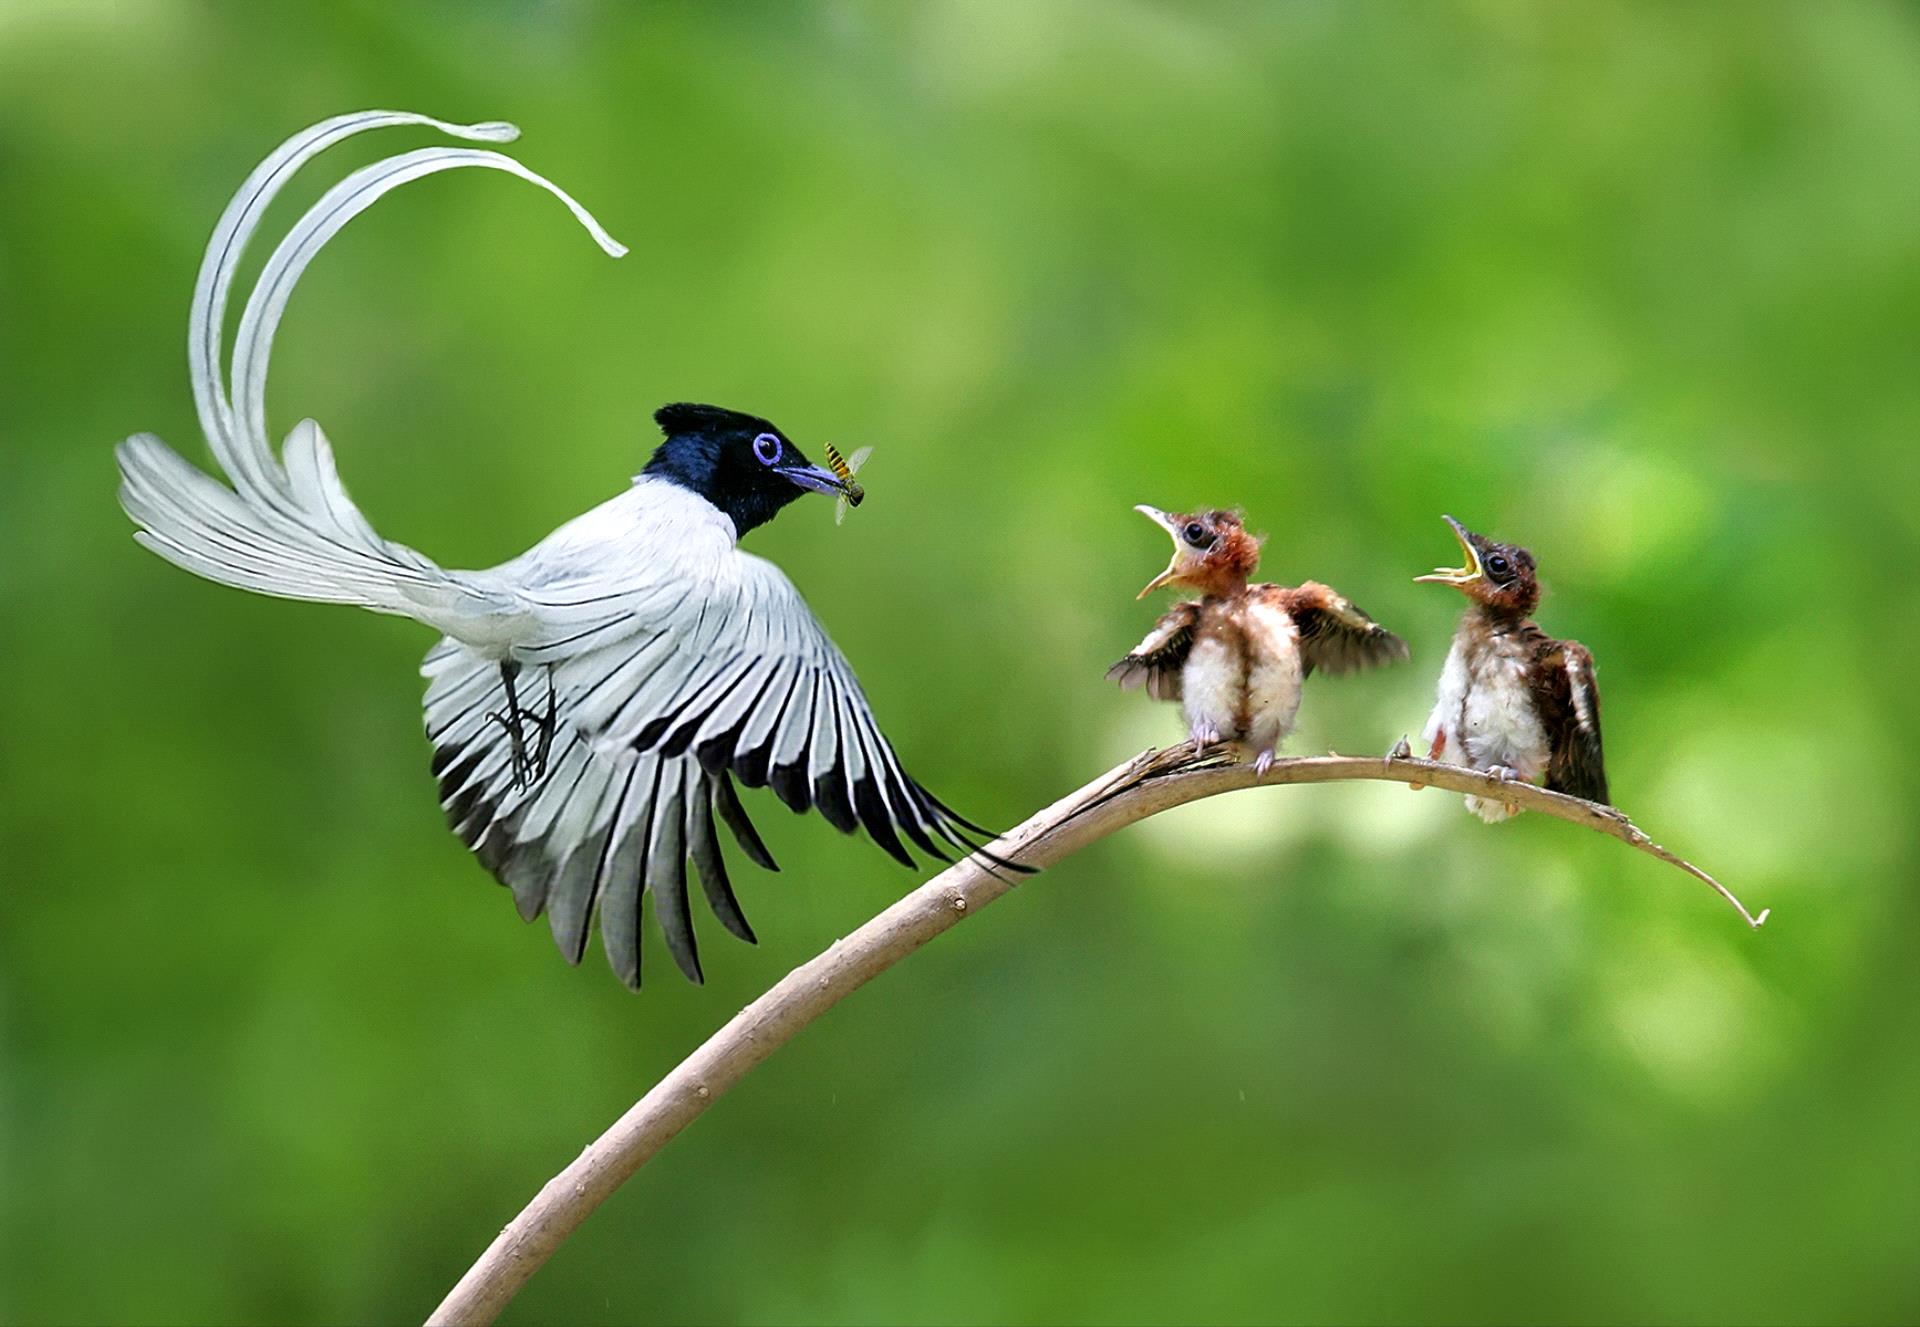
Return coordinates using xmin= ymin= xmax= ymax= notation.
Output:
xmin=0 ymin=0 xmax=1920 ymax=1323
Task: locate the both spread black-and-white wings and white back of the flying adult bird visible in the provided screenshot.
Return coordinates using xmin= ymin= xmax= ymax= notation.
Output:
xmin=422 ymin=506 xmax=1013 ymax=985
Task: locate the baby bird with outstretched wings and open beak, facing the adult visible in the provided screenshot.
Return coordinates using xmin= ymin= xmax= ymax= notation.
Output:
xmin=1106 ymin=507 xmax=1407 ymax=774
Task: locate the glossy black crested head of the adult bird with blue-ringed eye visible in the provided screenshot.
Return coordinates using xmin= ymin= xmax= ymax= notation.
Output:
xmin=643 ymin=403 xmax=851 ymax=534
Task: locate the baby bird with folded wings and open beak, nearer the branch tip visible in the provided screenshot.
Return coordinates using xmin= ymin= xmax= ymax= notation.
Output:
xmin=1415 ymin=517 xmax=1607 ymax=824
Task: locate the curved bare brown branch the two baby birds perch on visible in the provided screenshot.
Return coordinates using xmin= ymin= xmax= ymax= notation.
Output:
xmin=426 ymin=747 xmax=1766 ymax=1325
